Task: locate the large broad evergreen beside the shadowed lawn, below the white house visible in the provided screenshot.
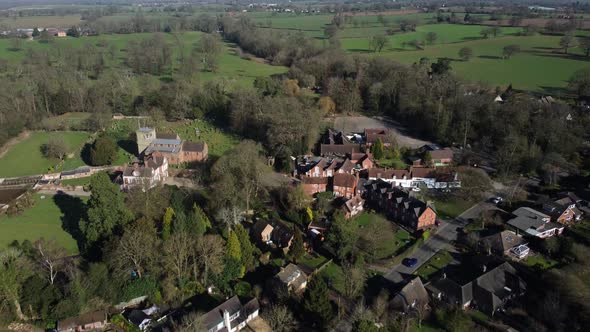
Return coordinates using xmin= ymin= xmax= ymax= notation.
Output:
xmin=80 ymin=172 xmax=133 ymax=244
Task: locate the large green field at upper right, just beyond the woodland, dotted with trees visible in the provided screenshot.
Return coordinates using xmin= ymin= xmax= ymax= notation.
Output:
xmin=341 ymin=24 xmax=589 ymax=94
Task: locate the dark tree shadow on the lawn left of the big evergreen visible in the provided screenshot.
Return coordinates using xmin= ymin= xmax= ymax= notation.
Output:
xmin=53 ymin=194 xmax=86 ymax=252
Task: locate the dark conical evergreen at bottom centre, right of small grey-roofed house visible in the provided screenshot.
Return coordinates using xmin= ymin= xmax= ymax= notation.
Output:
xmin=303 ymin=275 xmax=333 ymax=328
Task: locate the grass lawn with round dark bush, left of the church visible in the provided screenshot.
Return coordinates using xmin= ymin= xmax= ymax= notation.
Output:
xmin=0 ymin=131 xmax=89 ymax=177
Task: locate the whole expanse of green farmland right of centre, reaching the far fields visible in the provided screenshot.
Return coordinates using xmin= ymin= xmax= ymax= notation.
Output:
xmin=246 ymin=13 xmax=590 ymax=94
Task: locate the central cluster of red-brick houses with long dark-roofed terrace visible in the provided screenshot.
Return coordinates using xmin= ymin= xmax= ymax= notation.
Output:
xmin=295 ymin=128 xmax=461 ymax=231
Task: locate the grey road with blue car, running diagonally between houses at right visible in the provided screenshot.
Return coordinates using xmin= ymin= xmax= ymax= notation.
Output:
xmin=384 ymin=201 xmax=496 ymax=284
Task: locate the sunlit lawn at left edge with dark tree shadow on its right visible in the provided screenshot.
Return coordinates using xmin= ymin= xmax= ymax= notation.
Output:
xmin=0 ymin=195 xmax=85 ymax=254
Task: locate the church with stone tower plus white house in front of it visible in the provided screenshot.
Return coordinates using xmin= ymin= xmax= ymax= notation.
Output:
xmin=122 ymin=127 xmax=209 ymax=190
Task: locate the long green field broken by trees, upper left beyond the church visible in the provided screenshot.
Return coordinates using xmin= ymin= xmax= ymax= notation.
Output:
xmin=0 ymin=32 xmax=287 ymax=86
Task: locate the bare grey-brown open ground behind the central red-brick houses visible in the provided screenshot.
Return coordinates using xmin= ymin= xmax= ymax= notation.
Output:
xmin=334 ymin=116 xmax=430 ymax=148
